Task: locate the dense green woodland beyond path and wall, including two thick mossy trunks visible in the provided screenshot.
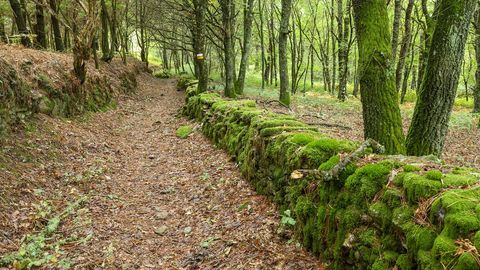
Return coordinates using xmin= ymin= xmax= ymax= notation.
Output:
xmin=0 ymin=0 xmax=480 ymax=155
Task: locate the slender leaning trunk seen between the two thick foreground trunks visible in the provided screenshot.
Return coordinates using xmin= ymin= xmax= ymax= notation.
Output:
xmin=395 ymin=0 xmax=415 ymax=91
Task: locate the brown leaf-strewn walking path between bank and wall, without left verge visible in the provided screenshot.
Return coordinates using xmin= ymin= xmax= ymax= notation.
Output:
xmin=63 ymin=74 xmax=321 ymax=269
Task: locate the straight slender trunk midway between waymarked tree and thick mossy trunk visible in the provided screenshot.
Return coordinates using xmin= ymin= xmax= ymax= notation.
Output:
xmin=278 ymin=0 xmax=292 ymax=106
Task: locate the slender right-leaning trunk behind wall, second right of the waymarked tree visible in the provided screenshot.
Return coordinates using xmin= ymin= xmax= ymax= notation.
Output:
xmin=235 ymin=0 xmax=260 ymax=95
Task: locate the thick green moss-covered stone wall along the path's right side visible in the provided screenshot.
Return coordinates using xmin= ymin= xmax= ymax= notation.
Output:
xmin=184 ymin=88 xmax=480 ymax=270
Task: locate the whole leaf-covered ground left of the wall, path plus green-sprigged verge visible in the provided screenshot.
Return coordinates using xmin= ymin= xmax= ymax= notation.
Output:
xmin=0 ymin=74 xmax=322 ymax=269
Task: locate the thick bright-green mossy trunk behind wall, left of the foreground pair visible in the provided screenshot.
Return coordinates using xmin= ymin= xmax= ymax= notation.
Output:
xmin=353 ymin=0 xmax=405 ymax=154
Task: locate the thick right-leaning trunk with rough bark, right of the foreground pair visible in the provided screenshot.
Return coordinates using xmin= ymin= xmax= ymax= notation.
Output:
xmin=407 ymin=0 xmax=477 ymax=156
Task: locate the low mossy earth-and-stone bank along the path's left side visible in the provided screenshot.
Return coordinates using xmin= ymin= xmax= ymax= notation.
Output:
xmin=0 ymin=56 xmax=141 ymax=135
